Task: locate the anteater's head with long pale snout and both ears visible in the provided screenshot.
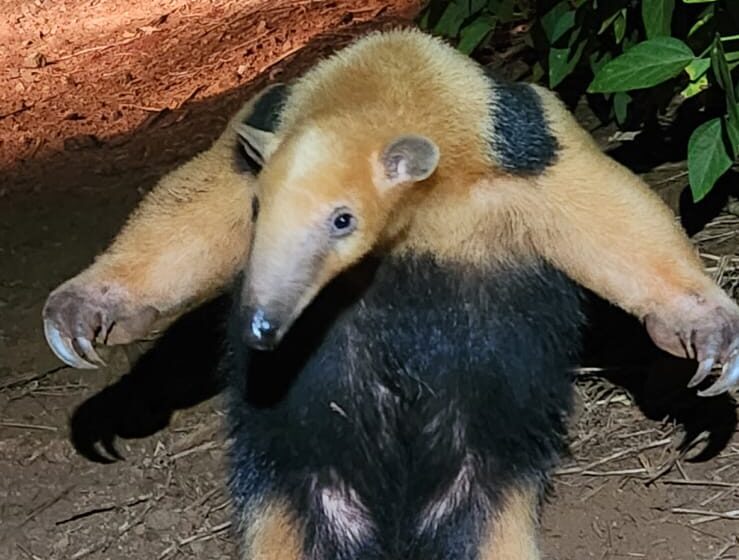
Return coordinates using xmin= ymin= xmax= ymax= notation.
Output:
xmin=238 ymin=118 xmax=439 ymax=349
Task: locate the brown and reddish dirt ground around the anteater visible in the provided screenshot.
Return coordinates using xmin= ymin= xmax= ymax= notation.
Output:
xmin=0 ymin=0 xmax=739 ymax=560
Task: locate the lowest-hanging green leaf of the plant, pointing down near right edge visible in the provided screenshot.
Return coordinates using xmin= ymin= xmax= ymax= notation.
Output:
xmin=688 ymin=118 xmax=732 ymax=202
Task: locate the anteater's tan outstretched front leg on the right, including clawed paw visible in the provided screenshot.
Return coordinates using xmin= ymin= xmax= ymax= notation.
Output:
xmin=526 ymin=87 xmax=739 ymax=396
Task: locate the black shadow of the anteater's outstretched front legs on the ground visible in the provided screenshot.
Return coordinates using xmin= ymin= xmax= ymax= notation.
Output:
xmin=66 ymin=284 xmax=737 ymax=462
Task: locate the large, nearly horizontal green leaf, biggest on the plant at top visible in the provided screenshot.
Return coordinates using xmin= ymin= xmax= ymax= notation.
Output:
xmin=588 ymin=37 xmax=695 ymax=93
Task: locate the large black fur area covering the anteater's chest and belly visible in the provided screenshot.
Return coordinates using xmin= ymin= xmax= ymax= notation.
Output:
xmin=223 ymin=258 xmax=582 ymax=560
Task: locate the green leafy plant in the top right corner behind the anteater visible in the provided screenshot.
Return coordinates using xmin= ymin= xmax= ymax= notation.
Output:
xmin=421 ymin=0 xmax=739 ymax=201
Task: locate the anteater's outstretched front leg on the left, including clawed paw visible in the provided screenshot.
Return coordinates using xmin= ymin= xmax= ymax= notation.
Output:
xmin=43 ymin=85 xmax=285 ymax=368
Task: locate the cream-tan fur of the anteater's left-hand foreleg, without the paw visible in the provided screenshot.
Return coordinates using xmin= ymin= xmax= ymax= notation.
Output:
xmin=73 ymin=99 xmax=254 ymax=324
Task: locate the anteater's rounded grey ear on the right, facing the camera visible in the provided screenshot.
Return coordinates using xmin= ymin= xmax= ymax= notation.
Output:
xmin=380 ymin=134 xmax=439 ymax=187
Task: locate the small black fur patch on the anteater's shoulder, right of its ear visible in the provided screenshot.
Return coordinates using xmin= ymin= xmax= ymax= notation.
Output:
xmin=488 ymin=72 xmax=559 ymax=175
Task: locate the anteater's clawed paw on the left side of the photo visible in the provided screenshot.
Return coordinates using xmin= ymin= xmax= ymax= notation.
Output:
xmin=43 ymin=282 xmax=158 ymax=369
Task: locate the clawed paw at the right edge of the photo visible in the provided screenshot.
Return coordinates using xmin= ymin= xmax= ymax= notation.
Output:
xmin=645 ymin=297 xmax=739 ymax=397
